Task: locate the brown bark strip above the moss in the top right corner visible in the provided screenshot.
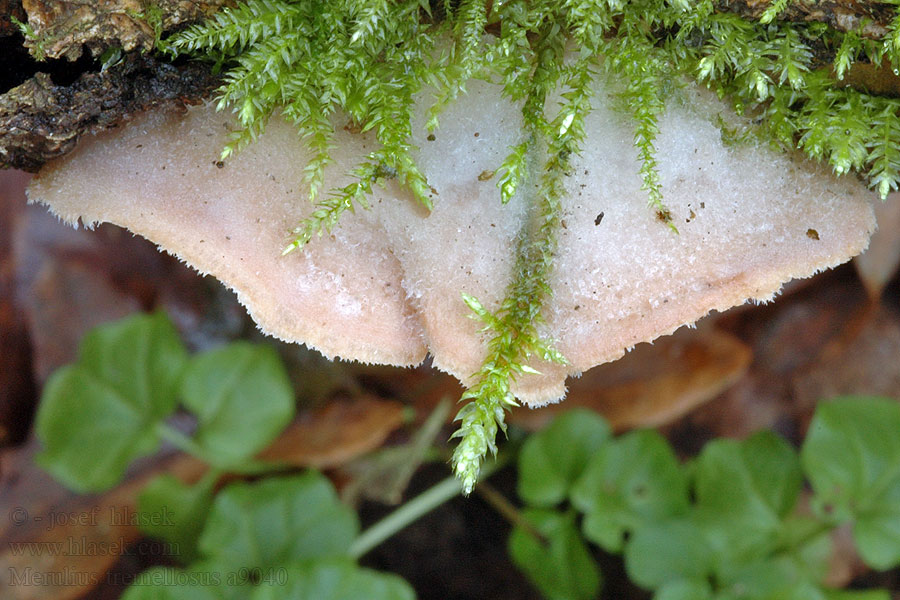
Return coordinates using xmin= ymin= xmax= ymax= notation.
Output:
xmin=717 ymin=0 xmax=896 ymax=38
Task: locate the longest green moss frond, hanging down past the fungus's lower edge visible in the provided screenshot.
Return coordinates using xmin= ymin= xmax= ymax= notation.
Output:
xmin=452 ymin=15 xmax=576 ymax=494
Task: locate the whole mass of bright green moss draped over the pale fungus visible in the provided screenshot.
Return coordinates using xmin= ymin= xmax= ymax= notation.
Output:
xmin=126 ymin=0 xmax=900 ymax=492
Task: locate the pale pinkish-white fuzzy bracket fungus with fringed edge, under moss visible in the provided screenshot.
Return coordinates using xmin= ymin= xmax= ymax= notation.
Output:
xmin=29 ymin=81 xmax=875 ymax=405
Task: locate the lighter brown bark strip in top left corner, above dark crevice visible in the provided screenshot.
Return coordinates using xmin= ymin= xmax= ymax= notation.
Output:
xmin=23 ymin=0 xmax=225 ymax=60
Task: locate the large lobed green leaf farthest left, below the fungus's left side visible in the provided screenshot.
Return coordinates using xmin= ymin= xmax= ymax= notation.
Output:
xmin=35 ymin=314 xmax=187 ymax=492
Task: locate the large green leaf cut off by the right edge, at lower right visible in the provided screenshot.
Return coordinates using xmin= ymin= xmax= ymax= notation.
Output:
xmin=801 ymin=398 xmax=900 ymax=570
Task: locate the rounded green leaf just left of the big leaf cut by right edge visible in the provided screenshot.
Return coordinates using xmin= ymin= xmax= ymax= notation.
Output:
xmin=694 ymin=432 xmax=803 ymax=560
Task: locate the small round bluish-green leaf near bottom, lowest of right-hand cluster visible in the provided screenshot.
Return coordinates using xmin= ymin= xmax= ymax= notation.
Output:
xmin=625 ymin=518 xmax=714 ymax=589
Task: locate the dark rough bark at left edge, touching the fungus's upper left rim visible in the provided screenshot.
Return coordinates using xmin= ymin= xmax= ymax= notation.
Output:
xmin=0 ymin=54 xmax=218 ymax=172
